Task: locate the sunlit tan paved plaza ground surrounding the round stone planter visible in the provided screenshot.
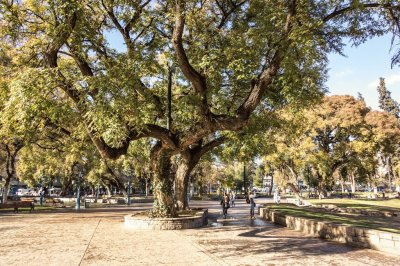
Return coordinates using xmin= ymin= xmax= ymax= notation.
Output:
xmin=0 ymin=198 xmax=400 ymax=266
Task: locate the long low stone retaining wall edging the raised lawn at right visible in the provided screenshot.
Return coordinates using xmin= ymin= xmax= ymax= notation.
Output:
xmin=259 ymin=208 xmax=400 ymax=255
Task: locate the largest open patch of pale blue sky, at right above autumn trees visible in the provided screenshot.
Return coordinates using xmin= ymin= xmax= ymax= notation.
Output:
xmin=327 ymin=35 xmax=400 ymax=109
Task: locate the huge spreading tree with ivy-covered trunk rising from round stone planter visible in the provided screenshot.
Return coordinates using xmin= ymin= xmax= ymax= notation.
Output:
xmin=0 ymin=0 xmax=398 ymax=216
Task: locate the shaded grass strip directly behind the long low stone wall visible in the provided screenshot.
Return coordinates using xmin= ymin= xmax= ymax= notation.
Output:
xmin=265 ymin=204 xmax=400 ymax=233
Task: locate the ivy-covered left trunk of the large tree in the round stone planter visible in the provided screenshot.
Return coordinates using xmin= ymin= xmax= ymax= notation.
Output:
xmin=151 ymin=143 xmax=177 ymax=217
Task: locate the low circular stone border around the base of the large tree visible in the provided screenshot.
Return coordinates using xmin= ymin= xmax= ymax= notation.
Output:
xmin=124 ymin=209 xmax=208 ymax=230
